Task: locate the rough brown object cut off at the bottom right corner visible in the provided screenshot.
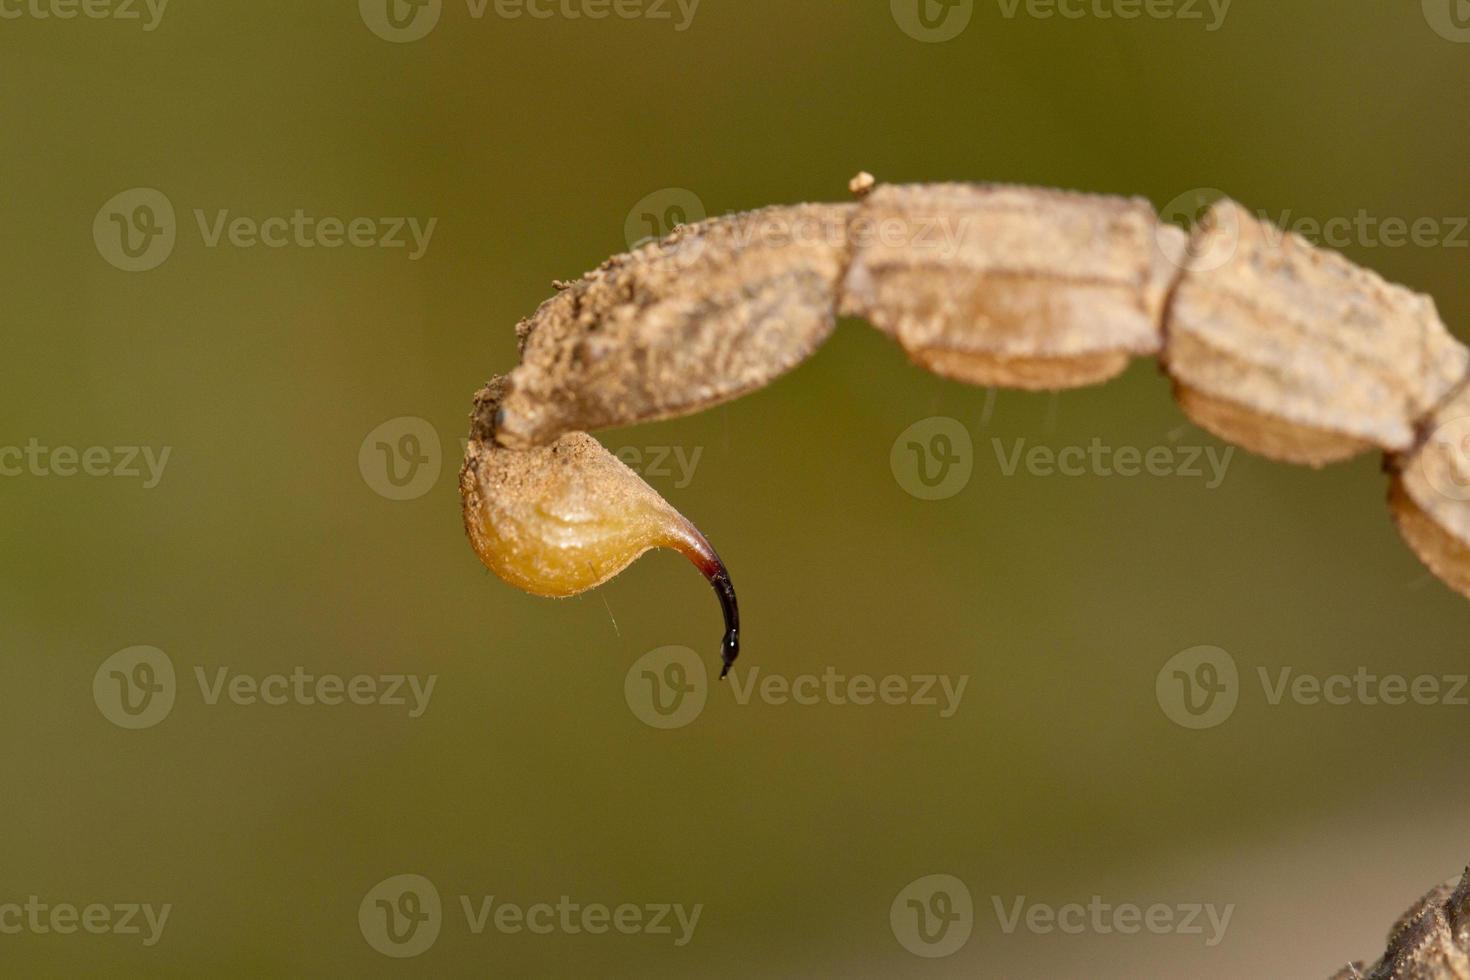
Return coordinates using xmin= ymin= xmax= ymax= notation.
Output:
xmin=1332 ymin=868 xmax=1470 ymax=980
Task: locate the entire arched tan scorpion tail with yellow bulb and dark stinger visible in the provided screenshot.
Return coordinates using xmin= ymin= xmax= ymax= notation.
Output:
xmin=462 ymin=175 xmax=1470 ymax=667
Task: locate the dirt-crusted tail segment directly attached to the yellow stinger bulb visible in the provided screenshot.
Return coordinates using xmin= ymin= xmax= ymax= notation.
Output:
xmin=498 ymin=204 xmax=857 ymax=448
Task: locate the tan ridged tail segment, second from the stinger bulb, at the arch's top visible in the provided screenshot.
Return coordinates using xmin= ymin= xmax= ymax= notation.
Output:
xmin=839 ymin=184 xmax=1185 ymax=389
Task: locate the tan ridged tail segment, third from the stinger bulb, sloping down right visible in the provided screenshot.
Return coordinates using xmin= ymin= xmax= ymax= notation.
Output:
xmin=1164 ymin=200 xmax=1470 ymax=466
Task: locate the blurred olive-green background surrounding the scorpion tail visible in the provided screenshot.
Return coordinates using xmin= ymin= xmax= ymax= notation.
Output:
xmin=0 ymin=0 xmax=1470 ymax=977
